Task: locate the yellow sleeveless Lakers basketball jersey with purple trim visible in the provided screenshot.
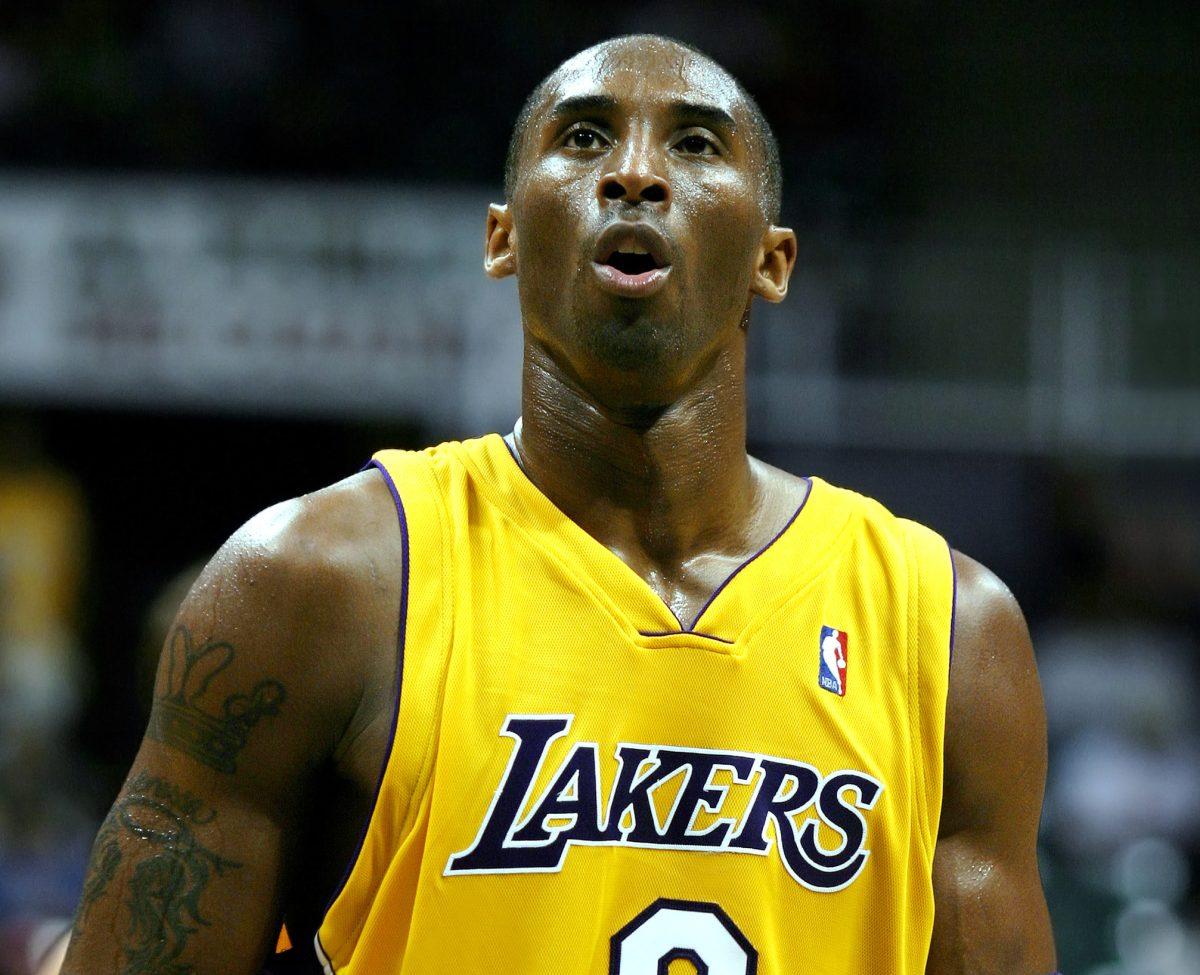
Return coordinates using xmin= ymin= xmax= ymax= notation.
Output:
xmin=314 ymin=435 xmax=954 ymax=975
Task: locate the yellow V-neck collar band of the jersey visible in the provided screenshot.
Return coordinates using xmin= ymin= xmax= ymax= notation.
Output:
xmin=458 ymin=433 xmax=848 ymax=656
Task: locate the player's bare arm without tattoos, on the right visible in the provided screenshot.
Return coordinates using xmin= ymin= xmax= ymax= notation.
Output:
xmin=926 ymin=552 xmax=1056 ymax=975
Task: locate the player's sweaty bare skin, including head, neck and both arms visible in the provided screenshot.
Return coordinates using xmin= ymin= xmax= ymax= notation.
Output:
xmin=64 ymin=37 xmax=1055 ymax=975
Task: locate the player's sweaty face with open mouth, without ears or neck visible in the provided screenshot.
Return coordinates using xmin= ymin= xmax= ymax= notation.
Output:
xmin=494 ymin=41 xmax=768 ymax=407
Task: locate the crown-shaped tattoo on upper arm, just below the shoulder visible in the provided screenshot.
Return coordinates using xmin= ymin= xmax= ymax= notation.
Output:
xmin=146 ymin=626 xmax=287 ymax=773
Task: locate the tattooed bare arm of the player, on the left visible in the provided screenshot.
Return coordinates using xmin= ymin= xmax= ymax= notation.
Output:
xmin=62 ymin=468 xmax=391 ymax=975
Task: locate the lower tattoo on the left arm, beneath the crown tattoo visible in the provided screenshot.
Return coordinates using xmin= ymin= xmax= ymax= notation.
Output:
xmin=74 ymin=772 xmax=241 ymax=975
